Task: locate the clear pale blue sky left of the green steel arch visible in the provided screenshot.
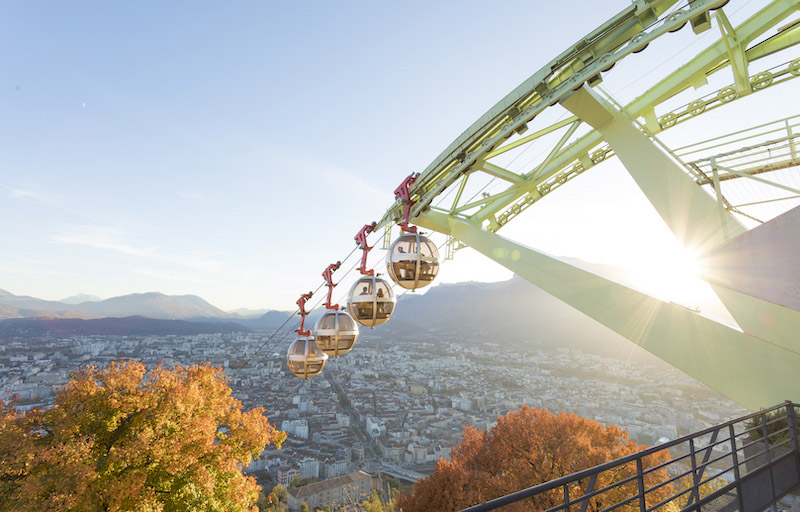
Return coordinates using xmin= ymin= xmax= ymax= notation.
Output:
xmin=0 ymin=0 xmax=792 ymax=309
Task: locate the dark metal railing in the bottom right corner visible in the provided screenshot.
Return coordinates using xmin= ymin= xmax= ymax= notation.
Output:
xmin=462 ymin=402 xmax=800 ymax=512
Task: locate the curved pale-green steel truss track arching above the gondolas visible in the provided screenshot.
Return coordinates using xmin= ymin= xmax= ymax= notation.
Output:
xmin=379 ymin=0 xmax=800 ymax=231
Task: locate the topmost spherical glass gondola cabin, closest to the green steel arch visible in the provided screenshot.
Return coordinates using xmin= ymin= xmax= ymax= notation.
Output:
xmin=386 ymin=233 xmax=439 ymax=290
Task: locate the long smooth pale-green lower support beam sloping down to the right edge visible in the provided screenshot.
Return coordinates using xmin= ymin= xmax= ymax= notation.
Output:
xmin=417 ymin=212 xmax=800 ymax=410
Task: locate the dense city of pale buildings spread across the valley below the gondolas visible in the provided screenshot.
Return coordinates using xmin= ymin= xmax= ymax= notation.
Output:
xmin=0 ymin=331 xmax=745 ymax=508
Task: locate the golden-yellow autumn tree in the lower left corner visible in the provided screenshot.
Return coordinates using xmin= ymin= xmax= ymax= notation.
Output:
xmin=0 ymin=361 xmax=286 ymax=512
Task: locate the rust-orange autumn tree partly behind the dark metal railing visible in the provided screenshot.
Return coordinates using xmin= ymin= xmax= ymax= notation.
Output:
xmin=398 ymin=406 xmax=671 ymax=512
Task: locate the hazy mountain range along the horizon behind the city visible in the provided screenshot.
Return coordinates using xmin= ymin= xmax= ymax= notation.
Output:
xmin=0 ymin=256 xmax=724 ymax=353
